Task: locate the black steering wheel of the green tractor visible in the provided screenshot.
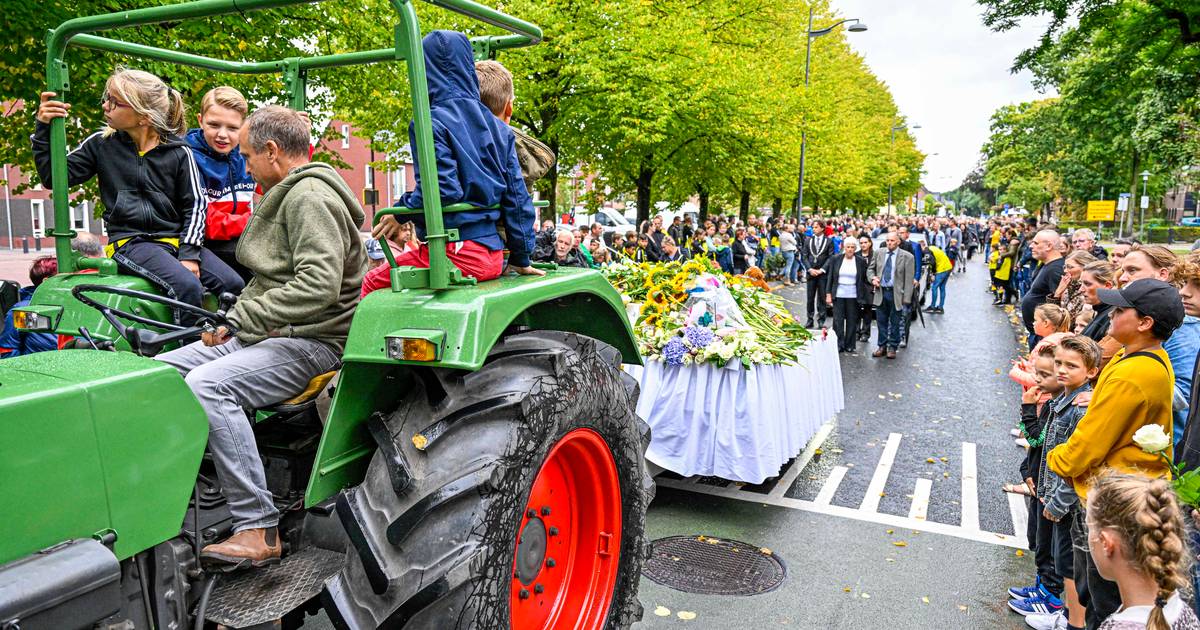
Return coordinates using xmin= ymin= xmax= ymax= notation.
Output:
xmin=71 ymin=284 xmax=238 ymax=356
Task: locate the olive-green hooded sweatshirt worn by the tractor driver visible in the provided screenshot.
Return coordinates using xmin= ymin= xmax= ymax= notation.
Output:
xmin=229 ymin=162 xmax=367 ymax=352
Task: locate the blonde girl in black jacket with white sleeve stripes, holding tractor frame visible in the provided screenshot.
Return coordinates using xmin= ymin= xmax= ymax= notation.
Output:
xmin=32 ymin=68 xmax=245 ymax=325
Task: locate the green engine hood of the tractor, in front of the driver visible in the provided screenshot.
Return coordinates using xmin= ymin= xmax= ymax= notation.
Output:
xmin=0 ymin=350 xmax=209 ymax=564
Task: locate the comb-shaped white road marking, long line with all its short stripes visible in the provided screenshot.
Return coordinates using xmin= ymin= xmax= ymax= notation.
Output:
xmin=655 ymin=419 xmax=1028 ymax=550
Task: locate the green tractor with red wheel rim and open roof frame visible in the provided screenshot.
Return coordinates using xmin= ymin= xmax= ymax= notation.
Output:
xmin=0 ymin=0 xmax=654 ymax=630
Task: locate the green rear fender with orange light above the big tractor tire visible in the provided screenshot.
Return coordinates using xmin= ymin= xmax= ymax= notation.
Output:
xmin=305 ymin=268 xmax=641 ymax=508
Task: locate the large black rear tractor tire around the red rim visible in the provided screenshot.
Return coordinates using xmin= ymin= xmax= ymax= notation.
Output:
xmin=323 ymin=331 xmax=654 ymax=630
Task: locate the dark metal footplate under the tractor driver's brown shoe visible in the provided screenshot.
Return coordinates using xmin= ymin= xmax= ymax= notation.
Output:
xmin=204 ymin=547 xmax=346 ymax=628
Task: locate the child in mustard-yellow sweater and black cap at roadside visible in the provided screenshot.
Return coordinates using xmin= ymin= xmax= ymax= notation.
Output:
xmin=1046 ymin=278 xmax=1183 ymax=629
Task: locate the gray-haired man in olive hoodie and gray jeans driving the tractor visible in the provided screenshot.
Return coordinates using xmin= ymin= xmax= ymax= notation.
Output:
xmin=158 ymin=106 xmax=367 ymax=571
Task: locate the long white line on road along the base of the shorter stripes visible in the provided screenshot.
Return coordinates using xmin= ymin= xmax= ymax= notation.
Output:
xmin=656 ymin=479 xmax=1028 ymax=550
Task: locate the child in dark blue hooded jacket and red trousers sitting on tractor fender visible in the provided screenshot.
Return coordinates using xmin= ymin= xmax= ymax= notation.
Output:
xmin=362 ymin=31 xmax=542 ymax=295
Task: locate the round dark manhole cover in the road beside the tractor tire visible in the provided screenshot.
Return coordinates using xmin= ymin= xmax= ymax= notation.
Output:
xmin=642 ymin=536 xmax=787 ymax=595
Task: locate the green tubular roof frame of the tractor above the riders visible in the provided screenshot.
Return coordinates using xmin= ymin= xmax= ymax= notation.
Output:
xmin=46 ymin=0 xmax=542 ymax=290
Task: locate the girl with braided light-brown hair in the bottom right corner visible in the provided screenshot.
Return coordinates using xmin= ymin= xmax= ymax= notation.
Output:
xmin=1087 ymin=473 xmax=1200 ymax=630
